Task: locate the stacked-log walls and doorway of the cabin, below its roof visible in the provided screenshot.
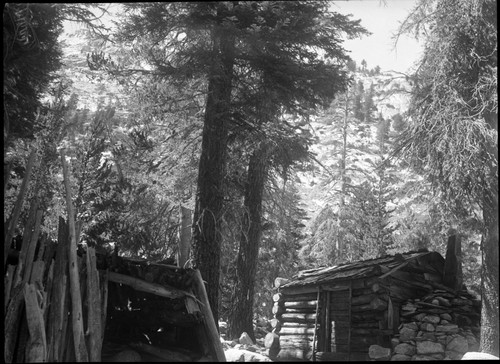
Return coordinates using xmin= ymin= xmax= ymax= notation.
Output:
xmin=266 ymin=278 xmax=392 ymax=360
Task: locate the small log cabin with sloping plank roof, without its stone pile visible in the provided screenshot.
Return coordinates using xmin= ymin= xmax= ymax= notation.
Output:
xmin=271 ymin=246 xmax=461 ymax=361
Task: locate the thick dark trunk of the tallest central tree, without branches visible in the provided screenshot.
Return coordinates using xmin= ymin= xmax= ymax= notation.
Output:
xmin=193 ymin=22 xmax=234 ymax=324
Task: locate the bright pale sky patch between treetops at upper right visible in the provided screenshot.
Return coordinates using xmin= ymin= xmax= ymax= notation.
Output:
xmin=331 ymin=0 xmax=422 ymax=73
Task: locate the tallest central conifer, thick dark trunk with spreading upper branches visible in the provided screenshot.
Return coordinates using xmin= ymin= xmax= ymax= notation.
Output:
xmin=116 ymin=1 xmax=364 ymax=321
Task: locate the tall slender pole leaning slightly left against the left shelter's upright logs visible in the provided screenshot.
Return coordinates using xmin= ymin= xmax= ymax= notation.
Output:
xmin=61 ymin=150 xmax=88 ymax=362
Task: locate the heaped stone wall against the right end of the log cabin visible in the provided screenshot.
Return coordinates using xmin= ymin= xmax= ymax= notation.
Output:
xmin=391 ymin=290 xmax=481 ymax=360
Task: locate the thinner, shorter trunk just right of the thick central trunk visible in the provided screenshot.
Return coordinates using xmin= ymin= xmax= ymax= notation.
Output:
xmin=228 ymin=146 xmax=267 ymax=342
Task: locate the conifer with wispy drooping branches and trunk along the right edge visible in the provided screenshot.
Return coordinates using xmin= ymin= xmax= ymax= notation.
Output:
xmin=396 ymin=0 xmax=499 ymax=356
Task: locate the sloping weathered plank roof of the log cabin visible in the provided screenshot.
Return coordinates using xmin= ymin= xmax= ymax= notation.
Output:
xmin=282 ymin=250 xmax=444 ymax=288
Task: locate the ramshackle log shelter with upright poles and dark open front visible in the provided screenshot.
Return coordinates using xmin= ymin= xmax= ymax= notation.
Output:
xmin=4 ymin=152 xmax=225 ymax=363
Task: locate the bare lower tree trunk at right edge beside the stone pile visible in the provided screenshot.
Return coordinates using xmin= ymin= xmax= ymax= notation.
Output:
xmin=480 ymin=110 xmax=500 ymax=356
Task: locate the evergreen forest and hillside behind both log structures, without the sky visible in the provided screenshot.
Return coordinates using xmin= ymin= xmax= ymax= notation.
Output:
xmin=3 ymin=0 xmax=499 ymax=355
